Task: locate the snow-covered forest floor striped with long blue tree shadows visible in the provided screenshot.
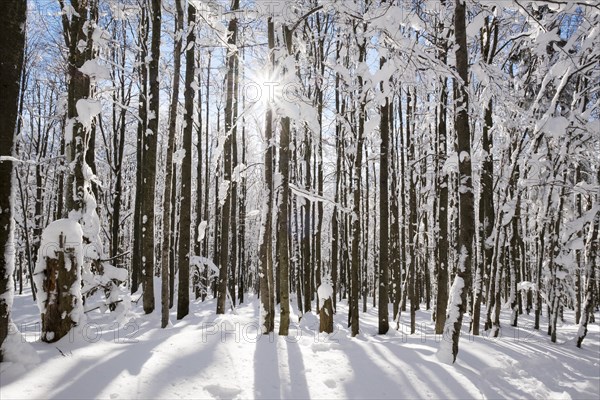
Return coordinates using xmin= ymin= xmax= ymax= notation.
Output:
xmin=0 ymin=282 xmax=600 ymax=399
